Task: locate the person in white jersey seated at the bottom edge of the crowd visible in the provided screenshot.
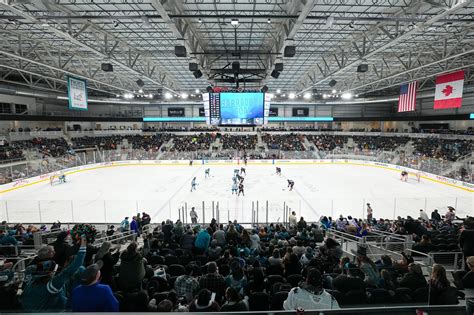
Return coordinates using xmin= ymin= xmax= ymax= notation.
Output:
xmin=283 ymin=268 xmax=340 ymax=311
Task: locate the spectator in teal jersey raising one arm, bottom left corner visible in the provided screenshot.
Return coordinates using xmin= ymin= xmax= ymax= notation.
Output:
xmin=20 ymin=237 xmax=87 ymax=312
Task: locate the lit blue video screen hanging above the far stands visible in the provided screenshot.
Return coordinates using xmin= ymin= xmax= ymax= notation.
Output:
xmin=219 ymin=92 xmax=264 ymax=125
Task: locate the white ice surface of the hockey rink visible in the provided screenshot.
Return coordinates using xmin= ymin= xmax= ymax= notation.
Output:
xmin=0 ymin=164 xmax=473 ymax=223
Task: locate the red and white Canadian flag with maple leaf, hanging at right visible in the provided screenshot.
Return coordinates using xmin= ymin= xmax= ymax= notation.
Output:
xmin=434 ymin=70 xmax=464 ymax=109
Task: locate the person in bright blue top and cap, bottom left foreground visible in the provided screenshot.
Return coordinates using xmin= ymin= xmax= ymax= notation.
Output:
xmin=71 ymin=260 xmax=119 ymax=312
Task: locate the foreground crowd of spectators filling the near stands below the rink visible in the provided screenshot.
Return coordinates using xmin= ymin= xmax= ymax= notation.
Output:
xmin=0 ymin=210 xmax=474 ymax=312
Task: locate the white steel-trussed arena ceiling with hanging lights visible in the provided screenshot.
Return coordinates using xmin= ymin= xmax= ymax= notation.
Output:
xmin=0 ymin=0 xmax=474 ymax=99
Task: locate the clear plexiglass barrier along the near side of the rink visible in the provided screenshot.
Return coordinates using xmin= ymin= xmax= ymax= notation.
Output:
xmin=0 ymin=197 xmax=473 ymax=224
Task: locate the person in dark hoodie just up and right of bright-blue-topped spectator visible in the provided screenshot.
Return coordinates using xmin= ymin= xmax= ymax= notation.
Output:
xmin=118 ymin=242 xmax=145 ymax=291
